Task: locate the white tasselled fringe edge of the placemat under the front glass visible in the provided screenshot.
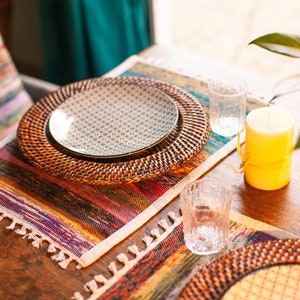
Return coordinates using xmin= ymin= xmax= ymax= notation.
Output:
xmin=72 ymin=211 xmax=182 ymax=300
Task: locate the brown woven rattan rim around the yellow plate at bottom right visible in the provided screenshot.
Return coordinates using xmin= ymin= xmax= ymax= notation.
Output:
xmin=179 ymin=239 xmax=300 ymax=300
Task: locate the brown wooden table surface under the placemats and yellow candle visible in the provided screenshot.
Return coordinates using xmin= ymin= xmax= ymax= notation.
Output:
xmin=0 ymin=46 xmax=300 ymax=299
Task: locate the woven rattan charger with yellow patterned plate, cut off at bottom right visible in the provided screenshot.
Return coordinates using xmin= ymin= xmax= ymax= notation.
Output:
xmin=179 ymin=239 xmax=300 ymax=300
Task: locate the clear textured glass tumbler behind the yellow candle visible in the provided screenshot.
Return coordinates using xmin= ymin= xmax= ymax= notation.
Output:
xmin=208 ymin=76 xmax=247 ymax=137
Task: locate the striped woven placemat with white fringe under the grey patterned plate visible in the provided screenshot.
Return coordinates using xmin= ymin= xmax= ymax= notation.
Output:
xmin=0 ymin=55 xmax=264 ymax=268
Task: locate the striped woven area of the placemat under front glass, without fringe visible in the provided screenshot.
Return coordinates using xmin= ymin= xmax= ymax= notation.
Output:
xmin=98 ymin=221 xmax=275 ymax=300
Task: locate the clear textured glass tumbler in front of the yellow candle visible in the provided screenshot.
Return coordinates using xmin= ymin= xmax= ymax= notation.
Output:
xmin=180 ymin=179 xmax=231 ymax=255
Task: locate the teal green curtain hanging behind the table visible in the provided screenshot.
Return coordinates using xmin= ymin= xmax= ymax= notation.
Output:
xmin=39 ymin=0 xmax=150 ymax=85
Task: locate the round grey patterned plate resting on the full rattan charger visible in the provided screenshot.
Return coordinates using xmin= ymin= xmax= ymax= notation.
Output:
xmin=49 ymin=84 xmax=178 ymax=157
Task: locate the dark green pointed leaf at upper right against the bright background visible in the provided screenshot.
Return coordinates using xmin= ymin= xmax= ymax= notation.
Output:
xmin=249 ymin=33 xmax=300 ymax=58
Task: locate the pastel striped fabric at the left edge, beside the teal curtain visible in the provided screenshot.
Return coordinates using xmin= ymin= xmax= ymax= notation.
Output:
xmin=0 ymin=36 xmax=33 ymax=140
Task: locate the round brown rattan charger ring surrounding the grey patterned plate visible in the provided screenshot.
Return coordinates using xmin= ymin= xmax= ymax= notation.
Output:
xmin=17 ymin=77 xmax=210 ymax=184
